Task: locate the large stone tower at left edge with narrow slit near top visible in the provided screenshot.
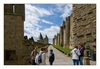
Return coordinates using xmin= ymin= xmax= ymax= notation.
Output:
xmin=4 ymin=4 xmax=25 ymax=64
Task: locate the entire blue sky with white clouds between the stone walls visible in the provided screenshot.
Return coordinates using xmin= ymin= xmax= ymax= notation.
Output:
xmin=24 ymin=4 xmax=72 ymax=43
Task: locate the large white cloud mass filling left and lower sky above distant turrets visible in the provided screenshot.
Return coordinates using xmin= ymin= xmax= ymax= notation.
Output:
xmin=24 ymin=4 xmax=59 ymax=43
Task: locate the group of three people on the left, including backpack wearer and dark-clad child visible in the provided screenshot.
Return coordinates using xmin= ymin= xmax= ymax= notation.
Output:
xmin=30 ymin=46 xmax=54 ymax=65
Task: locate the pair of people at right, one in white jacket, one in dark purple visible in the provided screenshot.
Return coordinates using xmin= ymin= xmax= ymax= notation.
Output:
xmin=71 ymin=43 xmax=85 ymax=65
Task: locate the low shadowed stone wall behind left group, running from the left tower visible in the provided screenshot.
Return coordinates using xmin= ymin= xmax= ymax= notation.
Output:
xmin=17 ymin=39 xmax=47 ymax=65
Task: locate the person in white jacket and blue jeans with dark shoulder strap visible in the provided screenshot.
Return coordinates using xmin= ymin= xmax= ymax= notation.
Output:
xmin=71 ymin=46 xmax=80 ymax=65
